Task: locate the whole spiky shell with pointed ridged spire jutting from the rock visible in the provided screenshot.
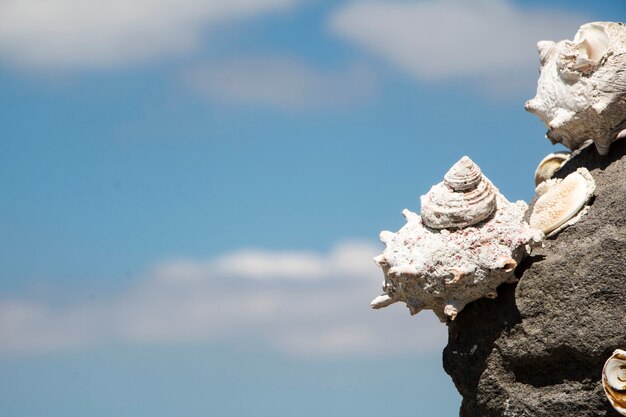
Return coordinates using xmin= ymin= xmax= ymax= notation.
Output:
xmin=371 ymin=157 xmax=543 ymax=322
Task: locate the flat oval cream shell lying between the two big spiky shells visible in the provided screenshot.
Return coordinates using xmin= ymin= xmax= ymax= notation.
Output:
xmin=529 ymin=168 xmax=596 ymax=236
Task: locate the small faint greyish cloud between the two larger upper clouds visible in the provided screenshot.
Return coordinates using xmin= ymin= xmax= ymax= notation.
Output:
xmin=183 ymin=57 xmax=376 ymax=110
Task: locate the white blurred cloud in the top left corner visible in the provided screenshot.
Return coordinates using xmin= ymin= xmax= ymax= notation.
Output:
xmin=0 ymin=0 xmax=297 ymax=69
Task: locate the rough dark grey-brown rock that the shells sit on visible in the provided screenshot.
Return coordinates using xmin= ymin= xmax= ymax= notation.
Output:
xmin=443 ymin=140 xmax=626 ymax=417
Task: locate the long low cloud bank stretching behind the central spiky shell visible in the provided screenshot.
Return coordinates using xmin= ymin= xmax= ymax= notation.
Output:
xmin=0 ymin=242 xmax=446 ymax=356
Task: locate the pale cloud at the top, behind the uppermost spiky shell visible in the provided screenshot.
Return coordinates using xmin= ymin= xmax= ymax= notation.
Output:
xmin=329 ymin=0 xmax=586 ymax=82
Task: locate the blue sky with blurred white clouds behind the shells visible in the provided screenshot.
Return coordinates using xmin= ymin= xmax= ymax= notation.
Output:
xmin=0 ymin=0 xmax=626 ymax=417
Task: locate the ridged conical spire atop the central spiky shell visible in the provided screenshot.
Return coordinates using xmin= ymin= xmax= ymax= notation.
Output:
xmin=420 ymin=156 xmax=496 ymax=229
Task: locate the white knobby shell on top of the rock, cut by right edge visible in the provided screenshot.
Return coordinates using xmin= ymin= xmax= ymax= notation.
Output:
xmin=526 ymin=22 xmax=626 ymax=155
